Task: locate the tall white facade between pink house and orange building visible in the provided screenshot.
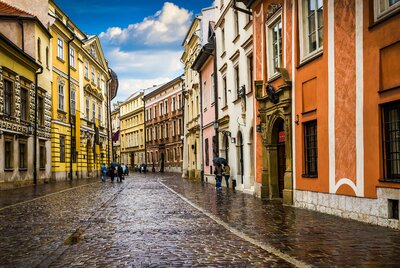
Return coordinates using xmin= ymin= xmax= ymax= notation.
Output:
xmin=215 ymin=1 xmax=255 ymax=194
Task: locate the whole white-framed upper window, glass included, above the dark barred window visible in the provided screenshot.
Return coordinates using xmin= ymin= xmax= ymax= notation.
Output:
xmin=299 ymin=0 xmax=324 ymax=59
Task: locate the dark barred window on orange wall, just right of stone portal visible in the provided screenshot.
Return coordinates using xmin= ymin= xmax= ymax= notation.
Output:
xmin=304 ymin=121 xmax=318 ymax=177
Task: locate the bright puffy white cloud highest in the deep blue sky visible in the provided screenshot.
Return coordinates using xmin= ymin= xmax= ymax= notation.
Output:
xmin=100 ymin=2 xmax=192 ymax=45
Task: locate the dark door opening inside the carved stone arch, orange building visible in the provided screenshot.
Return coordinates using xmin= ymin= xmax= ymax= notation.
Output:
xmin=271 ymin=118 xmax=286 ymax=198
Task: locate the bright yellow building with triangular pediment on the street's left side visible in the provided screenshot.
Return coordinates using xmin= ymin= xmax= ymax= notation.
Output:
xmin=48 ymin=0 xmax=110 ymax=180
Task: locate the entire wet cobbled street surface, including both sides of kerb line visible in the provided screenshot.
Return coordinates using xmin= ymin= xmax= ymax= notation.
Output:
xmin=0 ymin=174 xmax=400 ymax=267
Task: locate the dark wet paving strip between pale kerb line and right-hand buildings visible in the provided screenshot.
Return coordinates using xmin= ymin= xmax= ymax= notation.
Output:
xmin=163 ymin=175 xmax=400 ymax=267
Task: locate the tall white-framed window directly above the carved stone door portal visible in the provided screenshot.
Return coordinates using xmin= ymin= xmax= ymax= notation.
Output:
xmin=267 ymin=14 xmax=282 ymax=78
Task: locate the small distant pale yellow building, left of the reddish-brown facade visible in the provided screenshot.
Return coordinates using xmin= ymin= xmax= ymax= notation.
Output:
xmin=119 ymin=90 xmax=146 ymax=169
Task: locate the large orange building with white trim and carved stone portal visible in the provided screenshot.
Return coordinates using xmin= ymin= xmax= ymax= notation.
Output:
xmin=248 ymin=0 xmax=400 ymax=228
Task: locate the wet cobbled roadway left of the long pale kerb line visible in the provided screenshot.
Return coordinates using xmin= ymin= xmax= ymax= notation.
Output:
xmin=0 ymin=174 xmax=292 ymax=267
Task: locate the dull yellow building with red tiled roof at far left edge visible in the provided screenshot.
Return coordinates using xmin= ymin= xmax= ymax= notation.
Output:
xmin=0 ymin=2 xmax=51 ymax=188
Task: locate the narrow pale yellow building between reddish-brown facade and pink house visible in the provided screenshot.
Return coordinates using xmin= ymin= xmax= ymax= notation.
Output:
xmin=181 ymin=17 xmax=201 ymax=179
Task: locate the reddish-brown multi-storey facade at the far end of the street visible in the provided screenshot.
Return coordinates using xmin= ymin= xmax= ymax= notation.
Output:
xmin=144 ymin=76 xmax=183 ymax=172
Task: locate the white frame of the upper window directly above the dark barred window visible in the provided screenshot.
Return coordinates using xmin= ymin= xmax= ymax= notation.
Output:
xmin=298 ymin=0 xmax=326 ymax=63
